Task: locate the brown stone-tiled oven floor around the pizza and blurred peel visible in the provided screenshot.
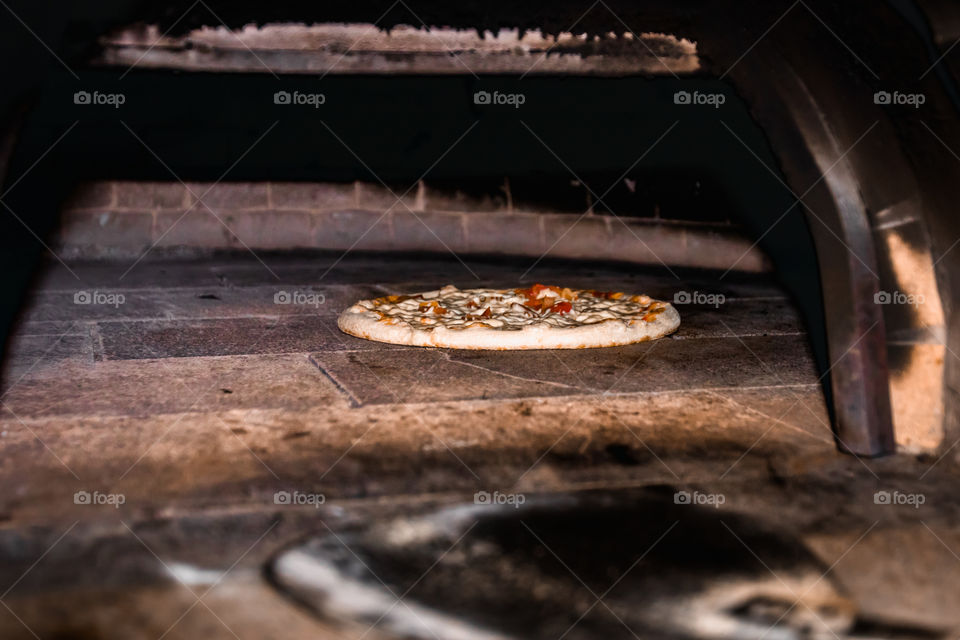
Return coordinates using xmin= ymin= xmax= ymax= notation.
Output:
xmin=0 ymin=255 xmax=960 ymax=638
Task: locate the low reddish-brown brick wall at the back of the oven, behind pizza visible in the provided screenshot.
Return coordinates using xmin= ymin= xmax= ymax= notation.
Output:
xmin=54 ymin=181 xmax=769 ymax=271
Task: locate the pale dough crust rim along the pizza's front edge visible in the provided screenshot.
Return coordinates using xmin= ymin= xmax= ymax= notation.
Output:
xmin=337 ymin=296 xmax=680 ymax=351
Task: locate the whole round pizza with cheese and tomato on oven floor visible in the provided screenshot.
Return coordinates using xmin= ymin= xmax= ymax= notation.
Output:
xmin=337 ymin=284 xmax=680 ymax=349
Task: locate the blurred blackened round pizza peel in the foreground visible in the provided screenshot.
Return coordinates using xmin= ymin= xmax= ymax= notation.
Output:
xmin=270 ymin=487 xmax=943 ymax=640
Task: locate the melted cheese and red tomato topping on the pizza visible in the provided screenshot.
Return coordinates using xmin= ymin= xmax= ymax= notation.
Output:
xmin=348 ymin=284 xmax=667 ymax=331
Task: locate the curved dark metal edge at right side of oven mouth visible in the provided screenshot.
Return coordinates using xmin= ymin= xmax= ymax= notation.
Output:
xmin=731 ymin=53 xmax=896 ymax=457
